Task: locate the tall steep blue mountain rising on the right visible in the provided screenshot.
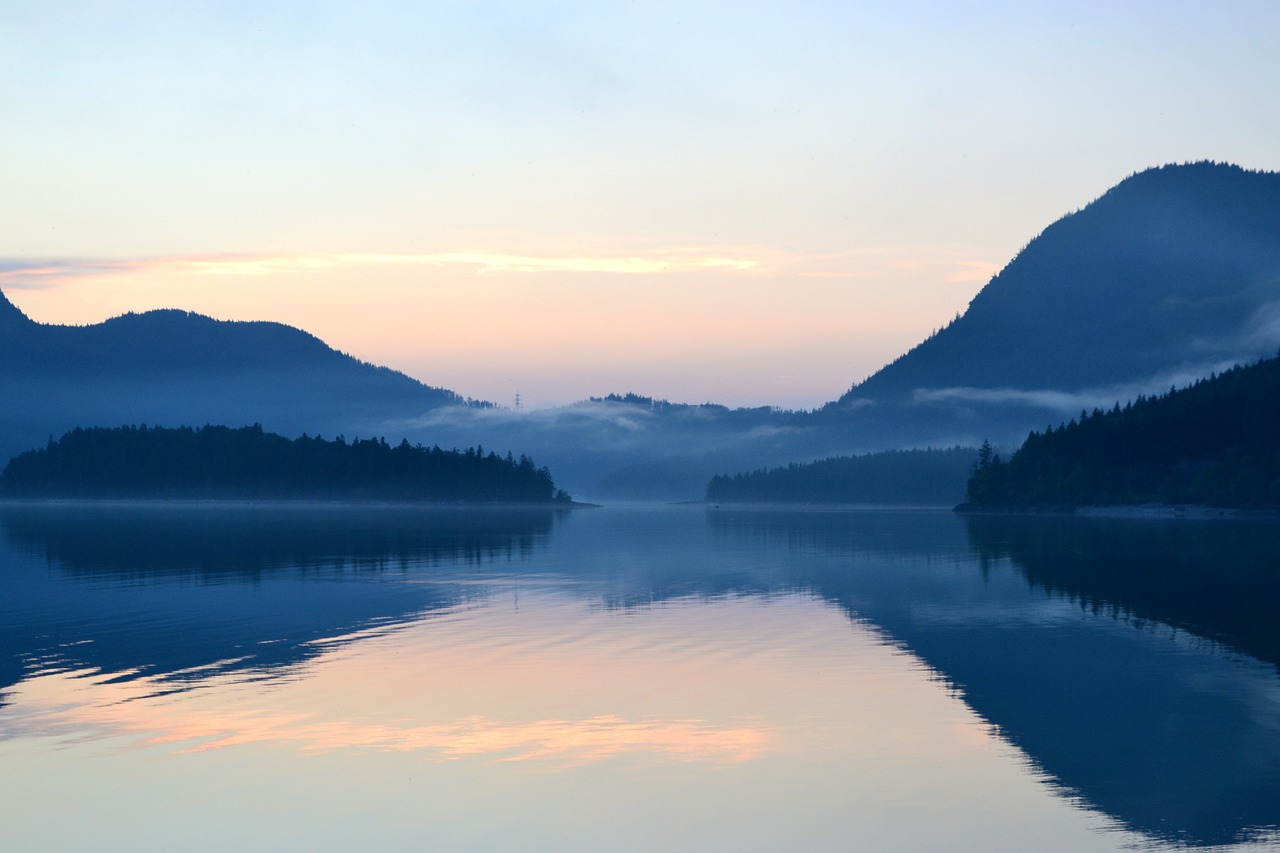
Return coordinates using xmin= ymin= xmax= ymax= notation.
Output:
xmin=831 ymin=163 xmax=1280 ymax=439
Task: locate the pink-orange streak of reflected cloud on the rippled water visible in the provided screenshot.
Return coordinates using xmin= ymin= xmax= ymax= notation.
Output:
xmin=10 ymin=655 xmax=768 ymax=765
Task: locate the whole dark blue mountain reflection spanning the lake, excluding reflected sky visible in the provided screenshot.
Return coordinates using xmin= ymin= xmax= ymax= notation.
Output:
xmin=0 ymin=505 xmax=1280 ymax=845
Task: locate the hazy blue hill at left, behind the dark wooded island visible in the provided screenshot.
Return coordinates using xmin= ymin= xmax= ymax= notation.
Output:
xmin=0 ymin=293 xmax=474 ymax=466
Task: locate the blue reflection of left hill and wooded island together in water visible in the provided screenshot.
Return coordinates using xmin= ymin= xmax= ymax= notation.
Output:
xmin=0 ymin=503 xmax=563 ymax=704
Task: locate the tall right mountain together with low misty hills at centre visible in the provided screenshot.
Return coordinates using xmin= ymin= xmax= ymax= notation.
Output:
xmin=404 ymin=163 xmax=1280 ymax=498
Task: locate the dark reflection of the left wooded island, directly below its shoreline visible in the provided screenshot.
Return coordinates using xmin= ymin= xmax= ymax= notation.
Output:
xmin=0 ymin=502 xmax=567 ymax=578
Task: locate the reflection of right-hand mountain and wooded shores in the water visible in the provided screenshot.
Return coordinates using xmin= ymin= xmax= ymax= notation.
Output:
xmin=708 ymin=511 xmax=1280 ymax=845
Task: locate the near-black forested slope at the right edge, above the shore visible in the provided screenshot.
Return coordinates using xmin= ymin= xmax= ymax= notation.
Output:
xmin=961 ymin=359 xmax=1280 ymax=508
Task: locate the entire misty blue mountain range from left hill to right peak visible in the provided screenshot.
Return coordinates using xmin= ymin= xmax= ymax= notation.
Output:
xmin=0 ymin=163 xmax=1280 ymax=500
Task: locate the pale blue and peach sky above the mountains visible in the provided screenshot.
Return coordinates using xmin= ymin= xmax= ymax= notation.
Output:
xmin=0 ymin=0 xmax=1280 ymax=409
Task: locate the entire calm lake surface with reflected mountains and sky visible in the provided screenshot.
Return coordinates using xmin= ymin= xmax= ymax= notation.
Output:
xmin=0 ymin=505 xmax=1280 ymax=852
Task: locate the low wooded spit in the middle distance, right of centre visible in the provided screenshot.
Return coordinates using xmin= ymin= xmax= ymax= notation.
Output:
xmin=707 ymin=447 xmax=978 ymax=506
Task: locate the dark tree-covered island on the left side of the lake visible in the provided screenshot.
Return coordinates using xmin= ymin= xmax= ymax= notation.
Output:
xmin=0 ymin=425 xmax=570 ymax=503
